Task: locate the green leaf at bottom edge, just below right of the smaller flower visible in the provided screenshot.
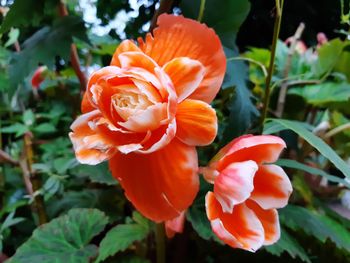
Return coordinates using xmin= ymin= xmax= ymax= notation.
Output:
xmin=265 ymin=228 xmax=311 ymax=263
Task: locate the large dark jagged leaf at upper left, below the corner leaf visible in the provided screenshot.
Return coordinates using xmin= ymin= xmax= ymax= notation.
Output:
xmin=9 ymin=16 xmax=88 ymax=85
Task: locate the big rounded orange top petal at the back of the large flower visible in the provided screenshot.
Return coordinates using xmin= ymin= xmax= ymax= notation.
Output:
xmin=138 ymin=14 xmax=226 ymax=103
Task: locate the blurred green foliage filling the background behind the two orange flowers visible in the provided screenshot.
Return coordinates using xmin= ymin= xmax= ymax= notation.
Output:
xmin=0 ymin=0 xmax=350 ymax=263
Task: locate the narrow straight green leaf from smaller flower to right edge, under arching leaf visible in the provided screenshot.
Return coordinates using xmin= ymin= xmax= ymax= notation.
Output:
xmin=276 ymin=159 xmax=350 ymax=188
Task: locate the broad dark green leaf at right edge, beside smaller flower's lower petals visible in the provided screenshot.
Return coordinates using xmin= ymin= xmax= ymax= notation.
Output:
xmin=279 ymin=205 xmax=350 ymax=250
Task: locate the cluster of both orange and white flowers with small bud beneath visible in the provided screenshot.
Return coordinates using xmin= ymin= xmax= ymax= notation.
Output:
xmin=69 ymin=14 xmax=291 ymax=251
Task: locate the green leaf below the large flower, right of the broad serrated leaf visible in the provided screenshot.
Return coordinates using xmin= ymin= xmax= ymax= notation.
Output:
xmin=96 ymin=214 xmax=151 ymax=263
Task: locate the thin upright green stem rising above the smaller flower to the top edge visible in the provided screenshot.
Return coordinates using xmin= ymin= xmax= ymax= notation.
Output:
xmin=260 ymin=0 xmax=284 ymax=131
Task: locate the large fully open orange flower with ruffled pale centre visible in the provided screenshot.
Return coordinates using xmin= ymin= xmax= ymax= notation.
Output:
xmin=70 ymin=14 xmax=226 ymax=221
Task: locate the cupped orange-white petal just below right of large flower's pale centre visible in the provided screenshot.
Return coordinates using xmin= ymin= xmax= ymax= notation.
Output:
xmin=118 ymin=103 xmax=168 ymax=132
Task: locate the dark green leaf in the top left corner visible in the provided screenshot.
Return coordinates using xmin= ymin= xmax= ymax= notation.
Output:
xmin=0 ymin=0 xmax=59 ymax=34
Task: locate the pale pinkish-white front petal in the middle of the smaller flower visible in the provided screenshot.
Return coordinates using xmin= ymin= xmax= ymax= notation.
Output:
xmin=214 ymin=161 xmax=258 ymax=213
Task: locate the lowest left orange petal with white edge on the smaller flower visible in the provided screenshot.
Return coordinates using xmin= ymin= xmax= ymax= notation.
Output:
xmin=205 ymin=192 xmax=264 ymax=252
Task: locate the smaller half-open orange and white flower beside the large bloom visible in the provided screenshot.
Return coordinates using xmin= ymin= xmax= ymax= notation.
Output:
xmin=202 ymin=135 xmax=292 ymax=251
